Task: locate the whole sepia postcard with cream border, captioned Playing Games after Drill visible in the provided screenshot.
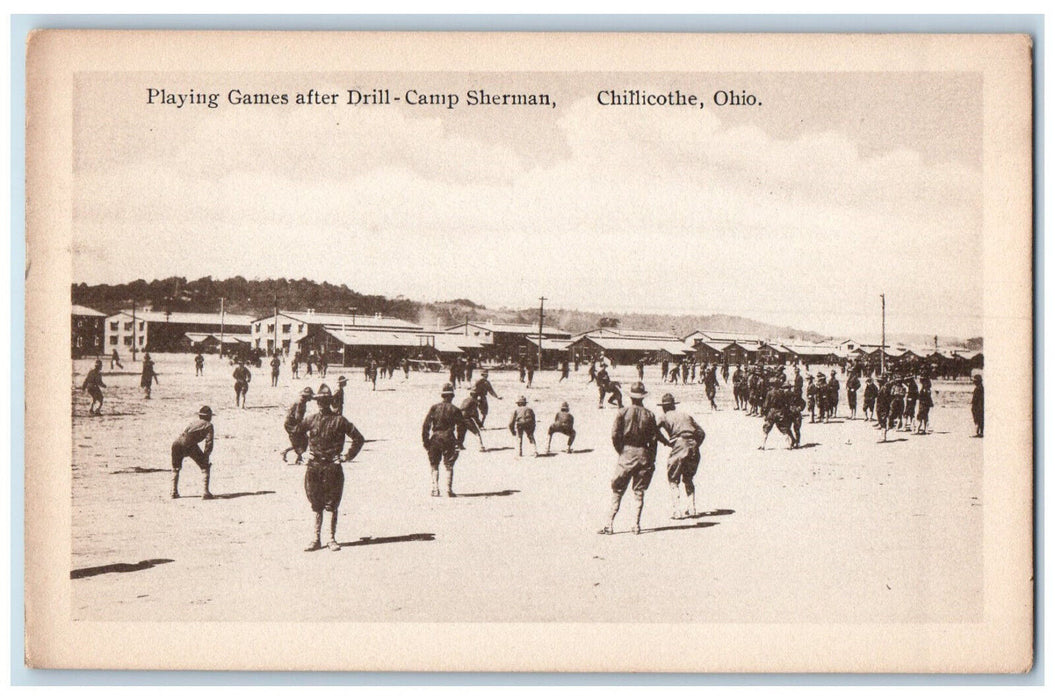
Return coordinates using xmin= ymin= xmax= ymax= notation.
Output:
xmin=25 ymin=31 xmax=1033 ymax=673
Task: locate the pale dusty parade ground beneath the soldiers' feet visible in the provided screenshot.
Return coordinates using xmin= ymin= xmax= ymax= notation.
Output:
xmin=71 ymin=355 xmax=983 ymax=623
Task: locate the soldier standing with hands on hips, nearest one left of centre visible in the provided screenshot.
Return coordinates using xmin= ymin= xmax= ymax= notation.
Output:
xmin=296 ymin=384 xmax=366 ymax=551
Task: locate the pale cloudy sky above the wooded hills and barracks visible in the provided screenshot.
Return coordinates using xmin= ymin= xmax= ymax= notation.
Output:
xmin=73 ymin=73 xmax=982 ymax=336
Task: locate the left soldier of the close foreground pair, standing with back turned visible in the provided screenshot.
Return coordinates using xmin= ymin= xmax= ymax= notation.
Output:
xmin=600 ymin=382 xmax=658 ymax=534
